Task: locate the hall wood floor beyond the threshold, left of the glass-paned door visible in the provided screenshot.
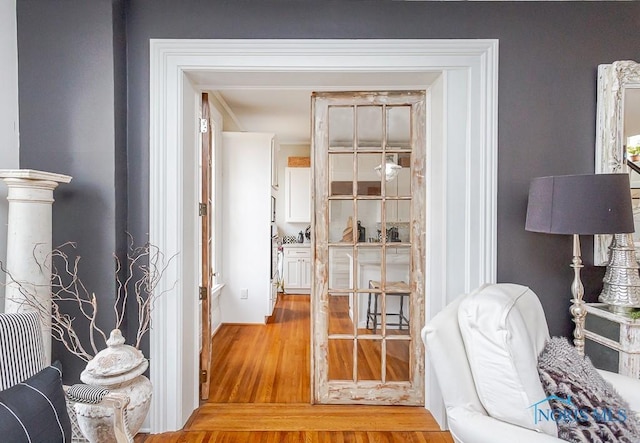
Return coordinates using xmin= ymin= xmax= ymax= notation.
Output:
xmin=208 ymin=294 xmax=311 ymax=403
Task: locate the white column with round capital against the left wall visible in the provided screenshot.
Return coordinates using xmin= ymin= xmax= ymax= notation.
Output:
xmin=0 ymin=169 xmax=71 ymax=363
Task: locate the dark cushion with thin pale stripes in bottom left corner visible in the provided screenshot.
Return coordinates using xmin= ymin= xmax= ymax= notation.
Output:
xmin=0 ymin=366 xmax=71 ymax=443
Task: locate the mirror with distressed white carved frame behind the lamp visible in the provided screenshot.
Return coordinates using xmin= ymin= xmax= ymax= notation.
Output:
xmin=593 ymin=60 xmax=640 ymax=266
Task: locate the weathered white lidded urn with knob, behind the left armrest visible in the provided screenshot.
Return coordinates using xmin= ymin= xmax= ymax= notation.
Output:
xmin=75 ymin=329 xmax=152 ymax=443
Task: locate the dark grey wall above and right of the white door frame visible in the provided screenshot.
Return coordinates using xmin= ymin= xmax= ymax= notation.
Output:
xmin=127 ymin=0 xmax=640 ymax=335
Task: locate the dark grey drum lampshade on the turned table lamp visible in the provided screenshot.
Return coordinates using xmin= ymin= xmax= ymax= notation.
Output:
xmin=525 ymin=174 xmax=634 ymax=234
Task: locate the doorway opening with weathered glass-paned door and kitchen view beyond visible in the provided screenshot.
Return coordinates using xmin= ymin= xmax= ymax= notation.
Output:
xmin=200 ymin=89 xmax=424 ymax=405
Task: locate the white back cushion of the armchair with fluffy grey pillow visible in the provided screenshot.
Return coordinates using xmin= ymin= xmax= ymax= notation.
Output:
xmin=458 ymin=284 xmax=557 ymax=436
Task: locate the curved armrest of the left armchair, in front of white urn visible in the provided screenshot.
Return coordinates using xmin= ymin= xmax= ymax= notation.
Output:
xmin=63 ymin=384 xmax=133 ymax=443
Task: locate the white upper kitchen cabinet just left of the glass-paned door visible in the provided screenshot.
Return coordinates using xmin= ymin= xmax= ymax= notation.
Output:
xmin=284 ymin=168 xmax=311 ymax=223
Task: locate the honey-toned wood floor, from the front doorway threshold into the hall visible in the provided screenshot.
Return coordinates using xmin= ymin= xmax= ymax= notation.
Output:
xmin=135 ymin=295 xmax=453 ymax=443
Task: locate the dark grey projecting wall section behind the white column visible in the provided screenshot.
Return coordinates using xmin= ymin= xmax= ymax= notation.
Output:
xmin=17 ymin=0 xmax=126 ymax=380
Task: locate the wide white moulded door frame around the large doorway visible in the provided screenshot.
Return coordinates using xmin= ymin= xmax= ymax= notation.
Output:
xmin=149 ymin=40 xmax=498 ymax=433
